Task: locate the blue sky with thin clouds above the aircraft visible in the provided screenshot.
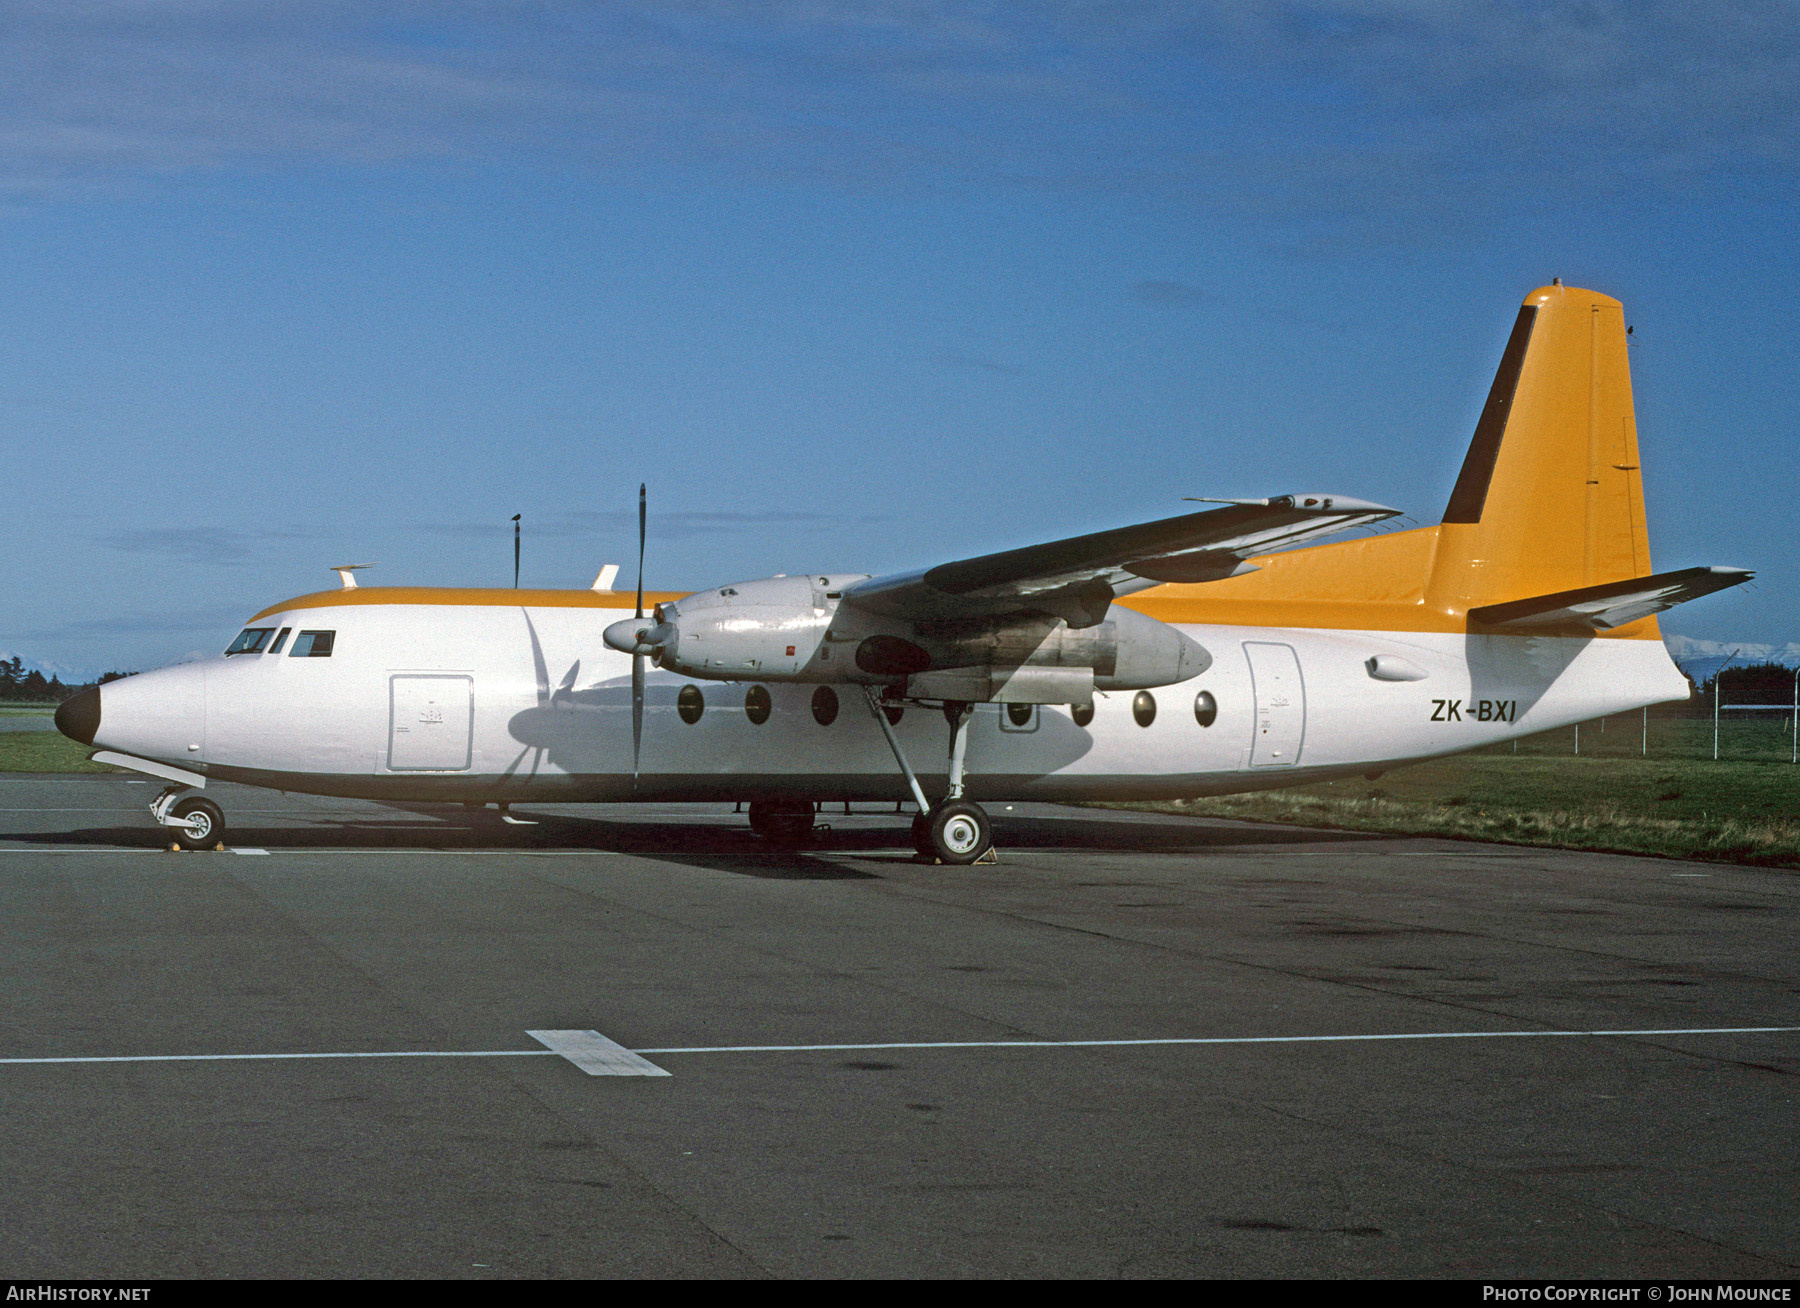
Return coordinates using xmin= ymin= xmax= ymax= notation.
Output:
xmin=0 ymin=0 xmax=1800 ymax=673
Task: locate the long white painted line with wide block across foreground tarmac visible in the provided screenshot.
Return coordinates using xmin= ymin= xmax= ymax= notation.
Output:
xmin=0 ymin=1026 xmax=1800 ymax=1076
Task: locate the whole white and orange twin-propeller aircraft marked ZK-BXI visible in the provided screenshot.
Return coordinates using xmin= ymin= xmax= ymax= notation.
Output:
xmin=56 ymin=282 xmax=1751 ymax=864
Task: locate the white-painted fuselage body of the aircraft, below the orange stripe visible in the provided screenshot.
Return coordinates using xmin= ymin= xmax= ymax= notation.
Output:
xmin=94 ymin=605 xmax=1688 ymax=802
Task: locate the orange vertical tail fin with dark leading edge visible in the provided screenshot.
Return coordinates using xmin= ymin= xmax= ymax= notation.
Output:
xmin=1427 ymin=284 xmax=1651 ymax=614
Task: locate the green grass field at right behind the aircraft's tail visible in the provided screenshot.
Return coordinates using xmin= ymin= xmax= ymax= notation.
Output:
xmin=1118 ymin=716 xmax=1800 ymax=867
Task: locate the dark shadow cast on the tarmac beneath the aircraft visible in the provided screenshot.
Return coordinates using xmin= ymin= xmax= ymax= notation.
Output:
xmin=0 ymin=804 xmax=1375 ymax=880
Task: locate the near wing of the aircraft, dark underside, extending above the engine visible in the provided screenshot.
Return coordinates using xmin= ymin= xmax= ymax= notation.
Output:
xmin=844 ymin=495 xmax=1399 ymax=628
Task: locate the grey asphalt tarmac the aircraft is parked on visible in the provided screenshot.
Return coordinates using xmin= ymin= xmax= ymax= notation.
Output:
xmin=0 ymin=777 xmax=1800 ymax=1281
